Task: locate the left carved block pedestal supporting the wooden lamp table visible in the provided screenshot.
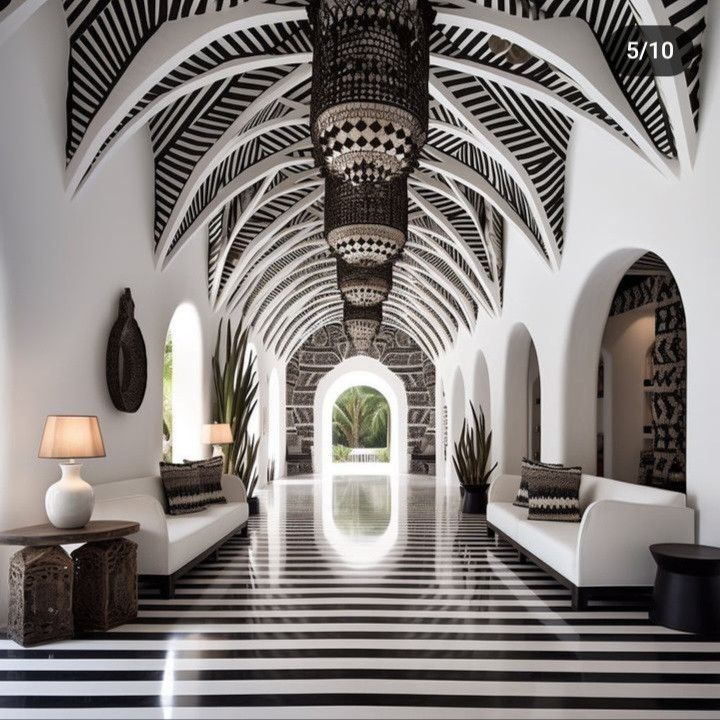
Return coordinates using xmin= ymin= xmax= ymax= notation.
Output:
xmin=8 ymin=547 xmax=73 ymax=646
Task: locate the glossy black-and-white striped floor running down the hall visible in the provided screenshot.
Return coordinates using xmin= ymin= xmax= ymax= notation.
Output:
xmin=0 ymin=477 xmax=720 ymax=719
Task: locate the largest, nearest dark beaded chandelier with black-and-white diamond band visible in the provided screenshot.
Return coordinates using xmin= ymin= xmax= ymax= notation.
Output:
xmin=308 ymin=0 xmax=435 ymax=184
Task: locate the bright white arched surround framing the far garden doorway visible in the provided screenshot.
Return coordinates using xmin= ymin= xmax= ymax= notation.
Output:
xmin=313 ymin=355 xmax=408 ymax=474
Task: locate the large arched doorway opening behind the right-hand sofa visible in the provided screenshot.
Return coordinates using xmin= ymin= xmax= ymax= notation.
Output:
xmin=597 ymin=253 xmax=687 ymax=492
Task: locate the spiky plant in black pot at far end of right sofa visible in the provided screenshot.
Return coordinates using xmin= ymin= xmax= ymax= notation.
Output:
xmin=452 ymin=403 xmax=497 ymax=513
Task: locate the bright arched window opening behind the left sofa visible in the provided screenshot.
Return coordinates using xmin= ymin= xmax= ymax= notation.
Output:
xmin=163 ymin=303 xmax=203 ymax=462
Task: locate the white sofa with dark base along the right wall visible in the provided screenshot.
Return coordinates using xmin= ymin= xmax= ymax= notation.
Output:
xmin=487 ymin=475 xmax=695 ymax=609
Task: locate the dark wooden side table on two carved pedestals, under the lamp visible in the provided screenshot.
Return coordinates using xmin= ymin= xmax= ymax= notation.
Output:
xmin=0 ymin=520 xmax=140 ymax=646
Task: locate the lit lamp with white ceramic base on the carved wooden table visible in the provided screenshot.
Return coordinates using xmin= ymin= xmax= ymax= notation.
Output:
xmin=38 ymin=415 xmax=105 ymax=529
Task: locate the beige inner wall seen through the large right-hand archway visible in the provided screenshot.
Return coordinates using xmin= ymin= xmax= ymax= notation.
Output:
xmin=598 ymin=305 xmax=655 ymax=482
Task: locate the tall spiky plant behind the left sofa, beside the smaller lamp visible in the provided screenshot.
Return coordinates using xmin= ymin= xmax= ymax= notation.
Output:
xmin=212 ymin=320 xmax=260 ymax=498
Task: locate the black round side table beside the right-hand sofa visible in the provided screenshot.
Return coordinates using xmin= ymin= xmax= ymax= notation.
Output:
xmin=650 ymin=543 xmax=720 ymax=635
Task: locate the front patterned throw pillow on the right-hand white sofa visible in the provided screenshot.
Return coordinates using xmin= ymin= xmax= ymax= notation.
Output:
xmin=527 ymin=466 xmax=582 ymax=522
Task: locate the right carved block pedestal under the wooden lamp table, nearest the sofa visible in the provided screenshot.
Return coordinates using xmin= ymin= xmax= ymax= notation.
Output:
xmin=72 ymin=539 xmax=137 ymax=631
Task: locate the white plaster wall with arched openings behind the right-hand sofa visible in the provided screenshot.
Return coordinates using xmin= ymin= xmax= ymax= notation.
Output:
xmin=438 ymin=3 xmax=720 ymax=545
